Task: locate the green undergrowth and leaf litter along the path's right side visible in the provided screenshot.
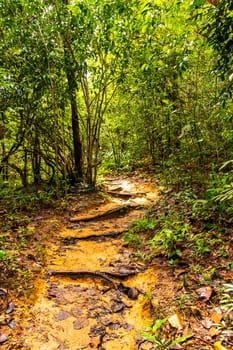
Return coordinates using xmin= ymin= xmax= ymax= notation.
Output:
xmin=125 ymin=174 xmax=233 ymax=349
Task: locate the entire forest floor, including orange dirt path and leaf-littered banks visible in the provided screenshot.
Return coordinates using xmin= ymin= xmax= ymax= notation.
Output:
xmin=0 ymin=177 xmax=233 ymax=350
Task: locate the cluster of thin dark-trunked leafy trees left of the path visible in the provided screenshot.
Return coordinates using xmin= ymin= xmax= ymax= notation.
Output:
xmin=0 ymin=0 xmax=147 ymax=186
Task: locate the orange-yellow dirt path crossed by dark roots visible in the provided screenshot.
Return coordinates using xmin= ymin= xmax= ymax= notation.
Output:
xmin=19 ymin=179 xmax=177 ymax=350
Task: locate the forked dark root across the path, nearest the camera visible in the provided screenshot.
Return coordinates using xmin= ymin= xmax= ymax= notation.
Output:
xmin=47 ymin=270 xmax=139 ymax=300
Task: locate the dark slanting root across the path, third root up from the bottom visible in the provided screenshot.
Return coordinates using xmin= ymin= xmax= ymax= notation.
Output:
xmin=70 ymin=204 xmax=138 ymax=222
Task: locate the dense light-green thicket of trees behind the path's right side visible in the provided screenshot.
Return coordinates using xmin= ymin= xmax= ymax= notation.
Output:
xmin=103 ymin=2 xmax=232 ymax=188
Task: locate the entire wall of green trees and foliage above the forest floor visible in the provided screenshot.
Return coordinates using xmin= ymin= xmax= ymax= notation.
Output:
xmin=0 ymin=0 xmax=233 ymax=205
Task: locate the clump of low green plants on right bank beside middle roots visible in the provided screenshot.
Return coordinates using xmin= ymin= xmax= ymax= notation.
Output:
xmin=125 ymin=197 xmax=227 ymax=264
